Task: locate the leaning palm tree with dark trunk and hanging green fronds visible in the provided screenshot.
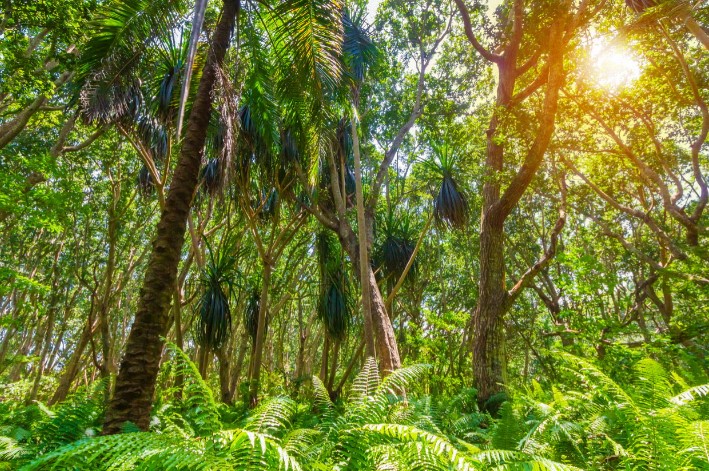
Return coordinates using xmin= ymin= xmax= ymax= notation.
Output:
xmin=73 ymin=0 xmax=340 ymax=434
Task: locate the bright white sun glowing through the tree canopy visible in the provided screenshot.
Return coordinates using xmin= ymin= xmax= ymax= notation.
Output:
xmin=588 ymin=41 xmax=641 ymax=91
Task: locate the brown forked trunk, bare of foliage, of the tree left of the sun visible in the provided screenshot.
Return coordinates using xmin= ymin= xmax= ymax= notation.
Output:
xmin=473 ymin=10 xmax=566 ymax=412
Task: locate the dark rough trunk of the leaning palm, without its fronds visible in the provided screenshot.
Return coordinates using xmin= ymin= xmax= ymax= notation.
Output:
xmin=103 ymin=0 xmax=239 ymax=434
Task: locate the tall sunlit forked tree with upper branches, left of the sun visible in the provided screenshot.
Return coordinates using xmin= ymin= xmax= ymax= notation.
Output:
xmin=456 ymin=0 xmax=602 ymax=409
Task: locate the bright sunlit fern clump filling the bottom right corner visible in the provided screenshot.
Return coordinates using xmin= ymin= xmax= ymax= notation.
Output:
xmin=506 ymin=354 xmax=709 ymax=469
